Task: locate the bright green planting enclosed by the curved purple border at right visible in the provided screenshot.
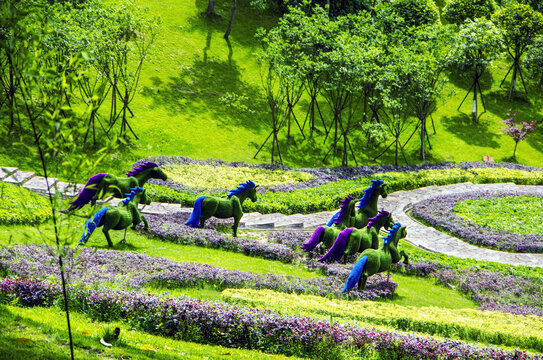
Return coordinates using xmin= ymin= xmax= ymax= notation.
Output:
xmin=453 ymin=196 xmax=543 ymax=235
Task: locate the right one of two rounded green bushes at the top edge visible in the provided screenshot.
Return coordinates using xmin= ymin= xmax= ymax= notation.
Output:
xmin=443 ymin=0 xmax=496 ymax=25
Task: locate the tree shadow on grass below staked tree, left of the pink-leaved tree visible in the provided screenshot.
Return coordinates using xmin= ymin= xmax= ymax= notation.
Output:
xmin=441 ymin=114 xmax=499 ymax=148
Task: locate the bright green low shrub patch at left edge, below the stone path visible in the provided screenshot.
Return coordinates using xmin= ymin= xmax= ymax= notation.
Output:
xmin=0 ymin=183 xmax=51 ymax=225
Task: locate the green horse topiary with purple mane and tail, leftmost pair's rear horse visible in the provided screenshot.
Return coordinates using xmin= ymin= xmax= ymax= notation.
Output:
xmin=63 ymin=161 xmax=168 ymax=212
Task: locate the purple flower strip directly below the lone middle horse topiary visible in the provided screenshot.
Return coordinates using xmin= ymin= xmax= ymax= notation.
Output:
xmin=140 ymin=213 xmax=299 ymax=263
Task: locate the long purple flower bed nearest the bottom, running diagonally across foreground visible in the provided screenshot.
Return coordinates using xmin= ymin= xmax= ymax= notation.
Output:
xmin=0 ymin=281 xmax=543 ymax=360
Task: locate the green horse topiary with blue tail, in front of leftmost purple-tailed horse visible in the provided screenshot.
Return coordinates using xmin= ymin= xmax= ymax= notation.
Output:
xmin=79 ymin=186 xmax=149 ymax=247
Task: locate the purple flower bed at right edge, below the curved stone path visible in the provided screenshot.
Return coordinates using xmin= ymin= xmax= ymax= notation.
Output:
xmin=395 ymin=261 xmax=543 ymax=316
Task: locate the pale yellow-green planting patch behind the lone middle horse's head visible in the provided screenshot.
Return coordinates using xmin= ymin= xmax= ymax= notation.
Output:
xmin=164 ymin=164 xmax=313 ymax=191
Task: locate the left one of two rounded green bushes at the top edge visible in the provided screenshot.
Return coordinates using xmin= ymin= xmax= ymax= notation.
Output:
xmin=392 ymin=0 xmax=439 ymax=26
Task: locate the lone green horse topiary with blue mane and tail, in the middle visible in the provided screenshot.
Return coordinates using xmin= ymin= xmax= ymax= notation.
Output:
xmin=185 ymin=180 xmax=258 ymax=237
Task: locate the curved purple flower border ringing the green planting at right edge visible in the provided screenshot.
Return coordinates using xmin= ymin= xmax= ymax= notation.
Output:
xmin=412 ymin=191 xmax=543 ymax=253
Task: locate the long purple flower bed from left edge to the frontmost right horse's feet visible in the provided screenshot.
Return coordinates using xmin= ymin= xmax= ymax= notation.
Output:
xmin=0 ymin=245 xmax=398 ymax=300
